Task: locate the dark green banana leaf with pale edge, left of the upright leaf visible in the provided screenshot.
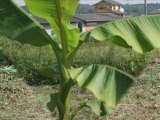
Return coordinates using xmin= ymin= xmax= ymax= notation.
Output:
xmin=0 ymin=0 xmax=52 ymax=46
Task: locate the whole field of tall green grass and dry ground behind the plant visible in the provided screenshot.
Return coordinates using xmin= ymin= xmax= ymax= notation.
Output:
xmin=0 ymin=37 xmax=160 ymax=120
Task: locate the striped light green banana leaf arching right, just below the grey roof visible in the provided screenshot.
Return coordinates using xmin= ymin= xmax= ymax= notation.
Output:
xmin=81 ymin=16 xmax=160 ymax=53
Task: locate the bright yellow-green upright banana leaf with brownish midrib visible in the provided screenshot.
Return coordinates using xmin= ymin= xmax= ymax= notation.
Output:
xmin=25 ymin=0 xmax=80 ymax=58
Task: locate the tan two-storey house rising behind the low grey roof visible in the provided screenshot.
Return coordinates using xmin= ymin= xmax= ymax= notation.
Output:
xmin=94 ymin=0 xmax=125 ymax=16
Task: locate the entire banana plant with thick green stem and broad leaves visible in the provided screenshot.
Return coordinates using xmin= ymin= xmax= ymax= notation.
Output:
xmin=0 ymin=0 xmax=160 ymax=120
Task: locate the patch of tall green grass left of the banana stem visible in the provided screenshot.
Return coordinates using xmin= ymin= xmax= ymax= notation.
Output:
xmin=0 ymin=37 xmax=56 ymax=85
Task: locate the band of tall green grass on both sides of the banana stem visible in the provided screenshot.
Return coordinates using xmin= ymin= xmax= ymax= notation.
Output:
xmin=0 ymin=36 xmax=150 ymax=81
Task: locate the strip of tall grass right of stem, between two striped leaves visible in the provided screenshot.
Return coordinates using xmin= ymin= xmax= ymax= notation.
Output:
xmin=74 ymin=42 xmax=150 ymax=75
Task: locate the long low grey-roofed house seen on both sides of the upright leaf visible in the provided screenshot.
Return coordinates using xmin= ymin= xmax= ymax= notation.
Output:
xmin=20 ymin=2 xmax=122 ymax=35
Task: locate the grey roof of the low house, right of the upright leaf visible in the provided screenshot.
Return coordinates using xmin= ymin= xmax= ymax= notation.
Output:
xmin=74 ymin=13 xmax=121 ymax=23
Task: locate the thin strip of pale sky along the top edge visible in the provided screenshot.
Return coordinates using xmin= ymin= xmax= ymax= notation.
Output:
xmin=15 ymin=0 xmax=160 ymax=5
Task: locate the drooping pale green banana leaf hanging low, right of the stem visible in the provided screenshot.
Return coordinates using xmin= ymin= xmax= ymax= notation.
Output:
xmin=70 ymin=65 xmax=134 ymax=115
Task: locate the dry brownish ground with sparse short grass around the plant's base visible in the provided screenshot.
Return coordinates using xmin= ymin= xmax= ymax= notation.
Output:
xmin=0 ymin=63 xmax=160 ymax=120
